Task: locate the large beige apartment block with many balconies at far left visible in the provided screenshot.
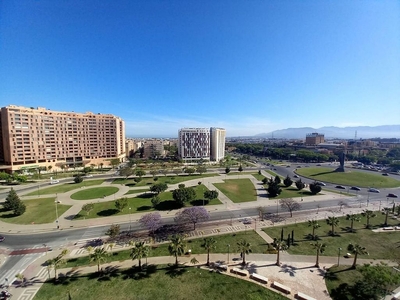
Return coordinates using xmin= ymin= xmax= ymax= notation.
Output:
xmin=0 ymin=105 xmax=125 ymax=171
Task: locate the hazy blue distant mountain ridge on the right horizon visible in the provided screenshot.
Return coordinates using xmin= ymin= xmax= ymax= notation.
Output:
xmin=255 ymin=125 xmax=400 ymax=139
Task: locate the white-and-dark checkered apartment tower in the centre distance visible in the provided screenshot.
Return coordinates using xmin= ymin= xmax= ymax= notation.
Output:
xmin=178 ymin=128 xmax=226 ymax=162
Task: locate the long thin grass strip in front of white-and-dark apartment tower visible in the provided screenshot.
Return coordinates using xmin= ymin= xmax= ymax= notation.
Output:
xmin=112 ymin=173 xmax=219 ymax=186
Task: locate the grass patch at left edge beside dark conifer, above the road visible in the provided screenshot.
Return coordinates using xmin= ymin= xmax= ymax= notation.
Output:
xmin=0 ymin=197 xmax=71 ymax=224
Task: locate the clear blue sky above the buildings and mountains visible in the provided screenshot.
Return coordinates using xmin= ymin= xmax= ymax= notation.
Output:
xmin=0 ymin=0 xmax=400 ymax=137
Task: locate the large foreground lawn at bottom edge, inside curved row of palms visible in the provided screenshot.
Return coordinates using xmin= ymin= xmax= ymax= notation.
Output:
xmin=34 ymin=265 xmax=287 ymax=300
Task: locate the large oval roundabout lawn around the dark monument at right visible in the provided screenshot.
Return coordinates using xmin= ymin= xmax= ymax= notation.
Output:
xmin=296 ymin=167 xmax=400 ymax=188
